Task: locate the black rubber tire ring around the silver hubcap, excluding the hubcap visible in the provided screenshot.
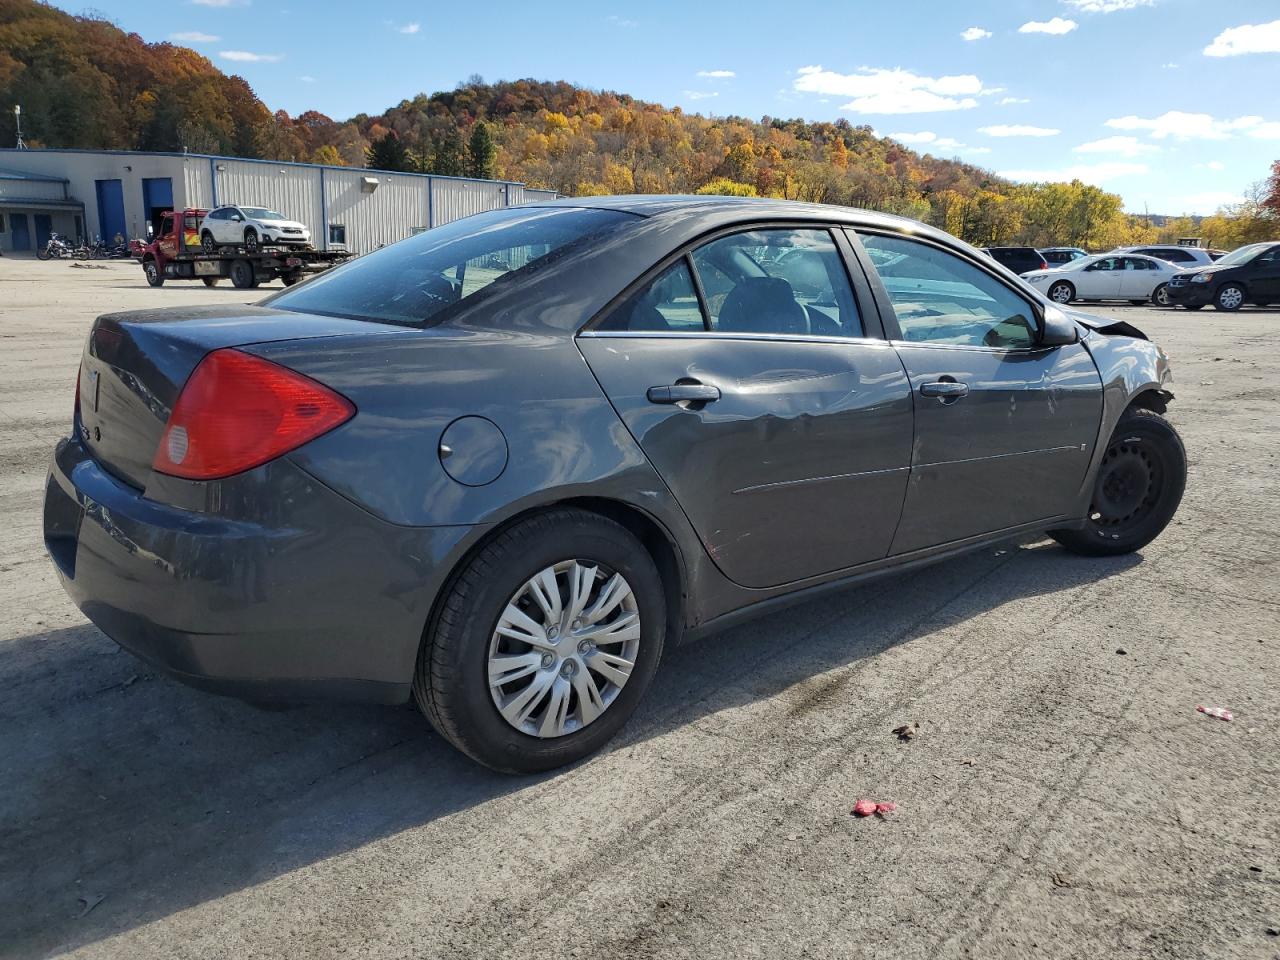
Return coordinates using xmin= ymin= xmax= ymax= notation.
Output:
xmin=430 ymin=513 xmax=667 ymax=773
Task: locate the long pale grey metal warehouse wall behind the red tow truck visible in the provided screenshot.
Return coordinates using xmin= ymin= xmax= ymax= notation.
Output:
xmin=0 ymin=150 xmax=557 ymax=253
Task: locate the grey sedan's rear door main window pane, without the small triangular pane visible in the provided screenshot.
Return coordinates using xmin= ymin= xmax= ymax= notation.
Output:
xmin=691 ymin=229 xmax=863 ymax=337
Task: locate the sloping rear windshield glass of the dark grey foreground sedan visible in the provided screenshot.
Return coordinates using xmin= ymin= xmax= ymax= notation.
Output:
xmin=264 ymin=207 xmax=635 ymax=326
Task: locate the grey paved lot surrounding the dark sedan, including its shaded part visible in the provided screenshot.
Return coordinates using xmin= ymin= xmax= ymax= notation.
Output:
xmin=0 ymin=259 xmax=1280 ymax=960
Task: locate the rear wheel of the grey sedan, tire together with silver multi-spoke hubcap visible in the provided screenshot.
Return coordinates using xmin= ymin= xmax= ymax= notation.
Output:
xmin=413 ymin=509 xmax=667 ymax=773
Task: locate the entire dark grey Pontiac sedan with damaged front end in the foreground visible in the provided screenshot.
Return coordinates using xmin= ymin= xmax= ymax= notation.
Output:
xmin=45 ymin=197 xmax=1185 ymax=772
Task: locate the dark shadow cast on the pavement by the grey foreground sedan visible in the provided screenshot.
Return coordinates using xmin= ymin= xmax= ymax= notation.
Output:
xmin=0 ymin=544 xmax=1140 ymax=956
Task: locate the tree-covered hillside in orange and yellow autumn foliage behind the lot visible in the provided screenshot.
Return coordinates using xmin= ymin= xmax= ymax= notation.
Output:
xmin=0 ymin=0 xmax=1275 ymax=248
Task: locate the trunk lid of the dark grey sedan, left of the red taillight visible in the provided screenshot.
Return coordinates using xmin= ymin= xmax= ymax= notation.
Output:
xmin=79 ymin=305 xmax=402 ymax=490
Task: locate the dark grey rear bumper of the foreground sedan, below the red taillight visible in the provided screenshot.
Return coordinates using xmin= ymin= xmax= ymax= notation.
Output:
xmin=44 ymin=439 xmax=474 ymax=703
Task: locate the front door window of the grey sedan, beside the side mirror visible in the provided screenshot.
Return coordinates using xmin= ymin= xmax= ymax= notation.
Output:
xmin=860 ymin=233 xmax=1037 ymax=349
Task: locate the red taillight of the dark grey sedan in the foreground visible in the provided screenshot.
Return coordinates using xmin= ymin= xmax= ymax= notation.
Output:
xmin=151 ymin=349 xmax=356 ymax=480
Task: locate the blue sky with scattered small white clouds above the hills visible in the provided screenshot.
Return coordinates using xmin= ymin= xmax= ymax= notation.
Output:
xmin=63 ymin=0 xmax=1280 ymax=214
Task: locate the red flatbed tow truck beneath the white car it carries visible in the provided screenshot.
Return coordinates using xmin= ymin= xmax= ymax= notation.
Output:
xmin=138 ymin=209 xmax=352 ymax=289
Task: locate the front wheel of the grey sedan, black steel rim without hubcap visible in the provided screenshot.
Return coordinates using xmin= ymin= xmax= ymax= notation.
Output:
xmin=1050 ymin=407 xmax=1187 ymax=557
